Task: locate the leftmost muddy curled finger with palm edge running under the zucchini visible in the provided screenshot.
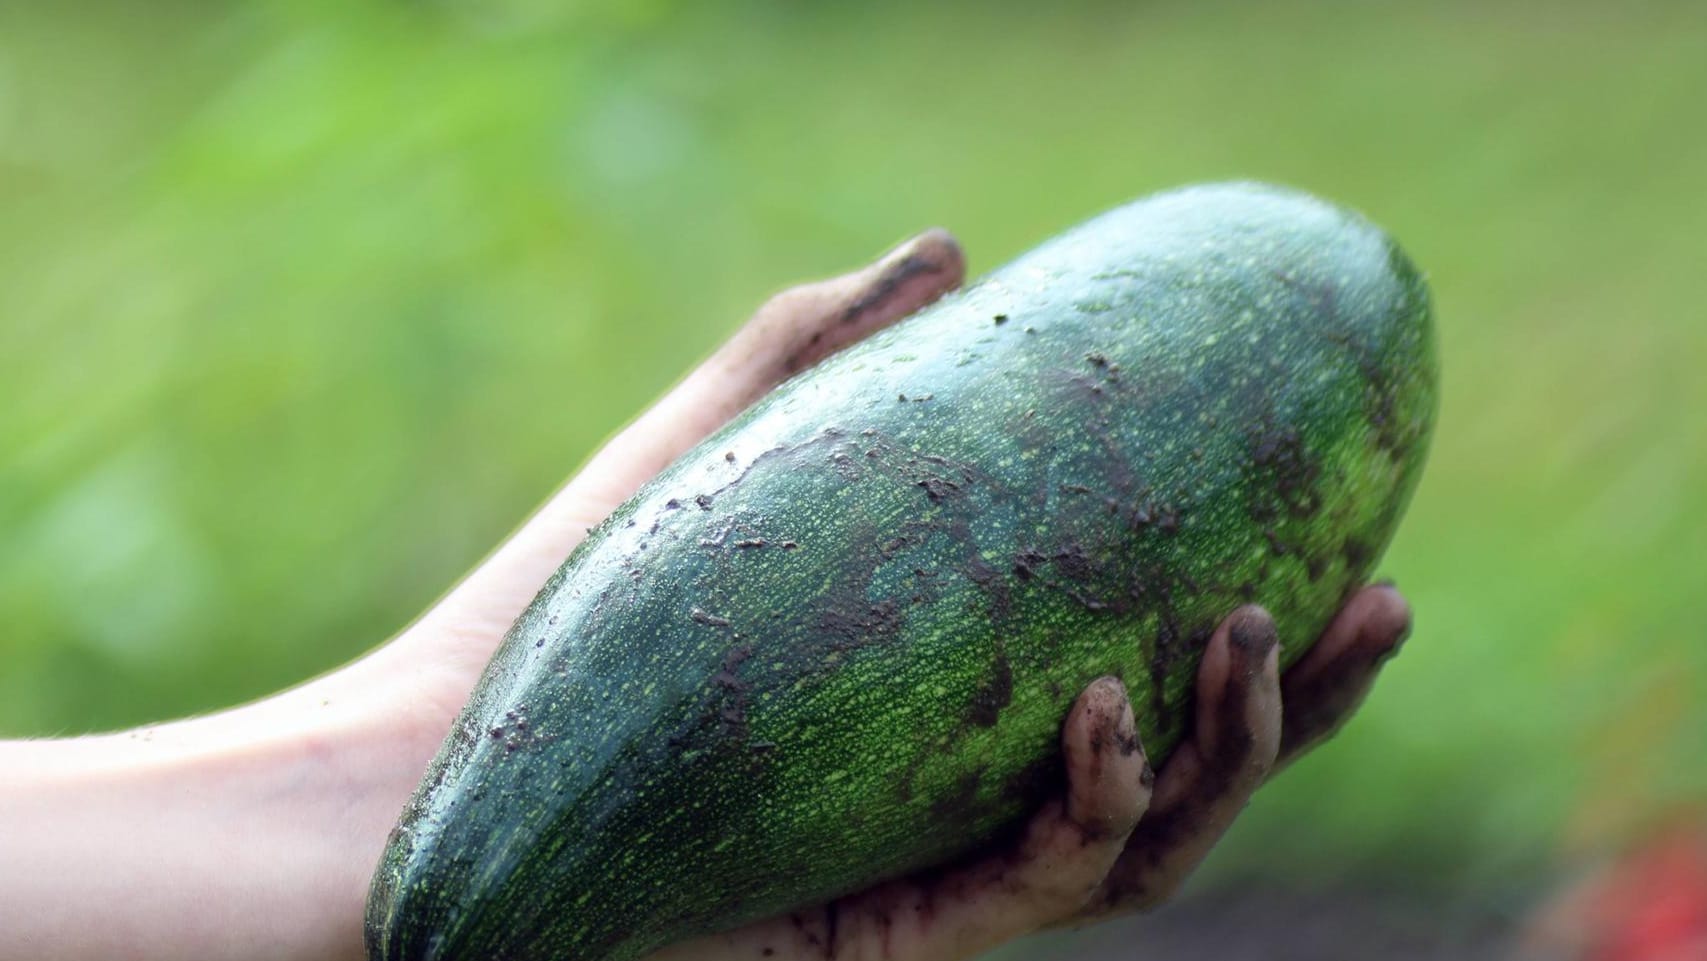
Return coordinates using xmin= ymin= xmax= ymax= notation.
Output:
xmin=649 ymin=678 xmax=1154 ymax=961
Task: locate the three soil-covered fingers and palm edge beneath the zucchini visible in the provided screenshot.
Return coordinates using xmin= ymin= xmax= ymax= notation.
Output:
xmin=647 ymin=585 xmax=1410 ymax=961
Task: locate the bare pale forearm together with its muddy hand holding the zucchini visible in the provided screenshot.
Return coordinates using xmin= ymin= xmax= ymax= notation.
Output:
xmin=0 ymin=230 xmax=1410 ymax=961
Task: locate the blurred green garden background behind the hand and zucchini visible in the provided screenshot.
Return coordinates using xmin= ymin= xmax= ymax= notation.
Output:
xmin=0 ymin=0 xmax=1707 ymax=935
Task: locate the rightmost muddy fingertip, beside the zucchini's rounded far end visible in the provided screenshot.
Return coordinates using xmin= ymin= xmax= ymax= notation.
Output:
xmin=1279 ymin=584 xmax=1410 ymax=766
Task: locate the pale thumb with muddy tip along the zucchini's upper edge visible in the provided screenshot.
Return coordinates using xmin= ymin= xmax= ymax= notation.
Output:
xmin=430 ymin=229 xmax=966 ymax=641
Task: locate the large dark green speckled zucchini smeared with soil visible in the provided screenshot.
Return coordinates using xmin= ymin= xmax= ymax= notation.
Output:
xmin=369 ymin=184 xmax=1436 ymax=961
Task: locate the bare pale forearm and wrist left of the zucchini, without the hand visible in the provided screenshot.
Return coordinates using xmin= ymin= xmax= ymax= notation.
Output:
xmin=0 ymin=679 xmax=437 ymax=961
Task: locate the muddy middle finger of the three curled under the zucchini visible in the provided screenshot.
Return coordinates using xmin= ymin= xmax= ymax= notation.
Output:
xmin=1086 ymin=606 xmax=1280 ymax=917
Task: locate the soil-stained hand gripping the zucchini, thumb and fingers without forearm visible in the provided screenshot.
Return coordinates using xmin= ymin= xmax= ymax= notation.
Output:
xmin=396 ymin=218 xmax=1410 ymax=961
